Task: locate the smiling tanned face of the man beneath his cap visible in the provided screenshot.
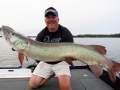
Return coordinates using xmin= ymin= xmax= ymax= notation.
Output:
xmin=45 ymin=13 xmax=59 ymax=29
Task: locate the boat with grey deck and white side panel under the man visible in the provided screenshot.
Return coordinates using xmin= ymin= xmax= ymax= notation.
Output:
xmin=0 ymin=60 xmax=120 ymax=90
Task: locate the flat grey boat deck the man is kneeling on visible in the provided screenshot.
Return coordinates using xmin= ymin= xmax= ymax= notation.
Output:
xmin=0 ymin=69 xmax=114 ymax=90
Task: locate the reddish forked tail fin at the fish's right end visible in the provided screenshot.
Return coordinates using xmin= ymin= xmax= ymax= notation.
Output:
xmin=108 ymin=61 xmax=120 ymax=83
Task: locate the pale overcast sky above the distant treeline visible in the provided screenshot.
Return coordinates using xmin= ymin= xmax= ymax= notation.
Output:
xmin=0 ymin=0 xmax=120 ymax=36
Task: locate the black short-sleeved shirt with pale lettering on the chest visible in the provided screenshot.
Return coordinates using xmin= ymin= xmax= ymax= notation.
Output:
xmin=36 ymin=25 xmax=74 ymax=64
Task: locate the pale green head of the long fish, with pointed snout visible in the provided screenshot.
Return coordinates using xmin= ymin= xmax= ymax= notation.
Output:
xmin=0 ymin=25 xmax=28 ymax=52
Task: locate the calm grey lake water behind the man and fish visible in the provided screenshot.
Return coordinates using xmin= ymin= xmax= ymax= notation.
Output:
xmin=0 ymin=38 xmax=120 ymax=67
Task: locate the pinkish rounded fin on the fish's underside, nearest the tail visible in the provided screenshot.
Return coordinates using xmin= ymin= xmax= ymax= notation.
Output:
xmin=89 ymin=64 xmax=103 ymax=77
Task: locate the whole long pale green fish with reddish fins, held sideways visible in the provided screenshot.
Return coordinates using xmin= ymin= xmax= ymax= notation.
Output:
xmin=0 ymin=26 xmax=120 ymax=83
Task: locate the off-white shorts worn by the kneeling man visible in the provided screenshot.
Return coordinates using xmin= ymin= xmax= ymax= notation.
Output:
xmin=33 ymin=61 xmax=71 ymax=79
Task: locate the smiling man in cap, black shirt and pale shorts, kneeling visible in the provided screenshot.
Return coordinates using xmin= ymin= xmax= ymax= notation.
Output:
xmin=29 ymin=7 xmax=73 ymax=90
